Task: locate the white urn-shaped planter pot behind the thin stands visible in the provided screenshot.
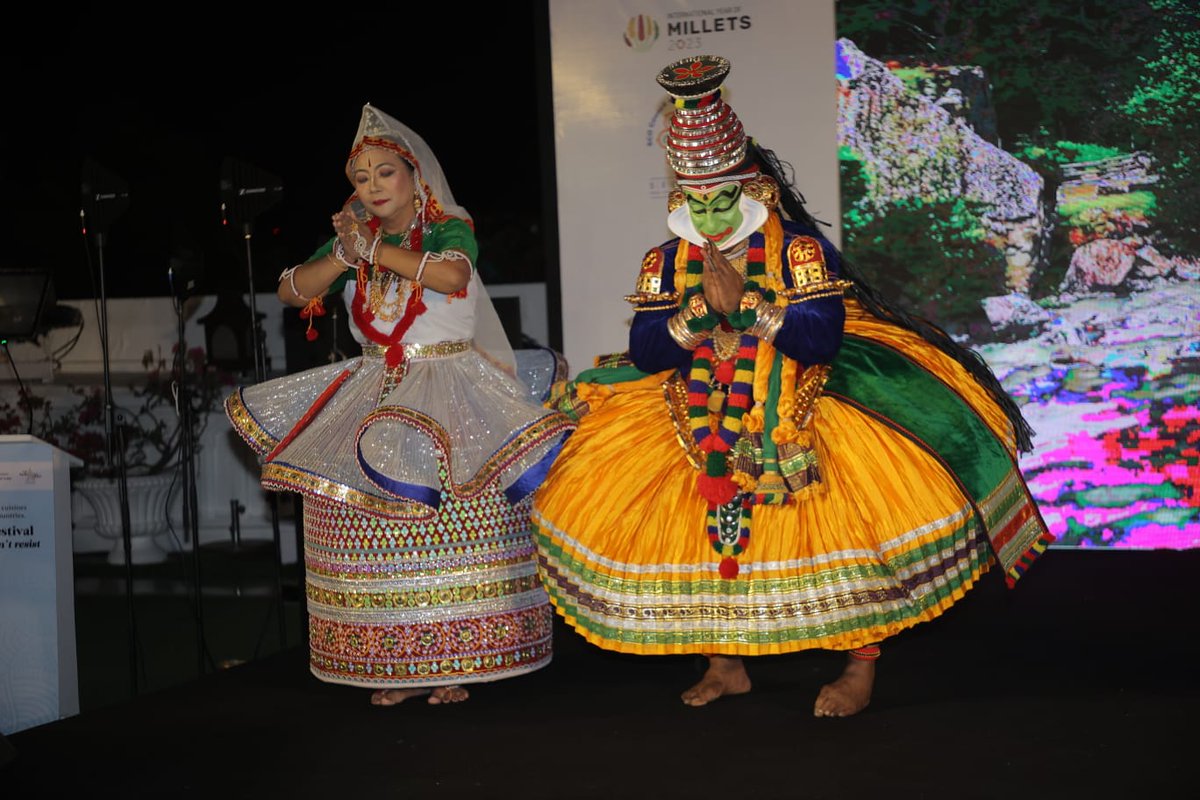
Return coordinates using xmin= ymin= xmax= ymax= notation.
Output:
xmin=73 ymin=473 xmax=178 ymax=565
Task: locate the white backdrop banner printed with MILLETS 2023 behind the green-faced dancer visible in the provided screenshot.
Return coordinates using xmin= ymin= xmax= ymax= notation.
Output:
xmin=550 ymin=0 xmax=840 ymax=375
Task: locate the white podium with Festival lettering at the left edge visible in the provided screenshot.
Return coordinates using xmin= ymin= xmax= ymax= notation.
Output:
xmin=0 ymin=437 xmax=82 ymax=734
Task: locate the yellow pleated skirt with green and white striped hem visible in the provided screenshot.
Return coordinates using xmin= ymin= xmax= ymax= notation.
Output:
xmin=533 ymin=307 xmax=1048 ymax=656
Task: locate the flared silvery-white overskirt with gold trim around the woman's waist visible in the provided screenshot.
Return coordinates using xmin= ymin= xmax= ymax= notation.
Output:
xmin=226 ymin=348 xmax=574 ymax=517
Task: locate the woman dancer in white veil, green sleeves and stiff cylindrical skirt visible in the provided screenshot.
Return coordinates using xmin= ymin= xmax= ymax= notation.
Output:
xmin=226 ymin=106 xmax=574 ymax=705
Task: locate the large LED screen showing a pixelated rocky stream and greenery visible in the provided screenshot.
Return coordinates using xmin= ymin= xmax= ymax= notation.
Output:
xmin=836 ymin=0 xmax=1200 ymax=548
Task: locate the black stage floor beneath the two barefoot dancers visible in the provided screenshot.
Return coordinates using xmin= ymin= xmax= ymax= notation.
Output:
xmin=0 ymin=551 xmax=1200 ymax=799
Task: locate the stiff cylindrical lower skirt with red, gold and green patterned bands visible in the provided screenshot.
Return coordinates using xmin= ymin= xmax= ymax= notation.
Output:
xmin=304 ymin=489 xmax=552 ymax=688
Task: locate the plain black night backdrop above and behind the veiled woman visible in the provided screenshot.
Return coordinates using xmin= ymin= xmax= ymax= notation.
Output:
xmin=0 ymin=2 xmax=548 ymax=299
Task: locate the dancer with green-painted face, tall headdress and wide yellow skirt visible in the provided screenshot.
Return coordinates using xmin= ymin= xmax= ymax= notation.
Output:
xmin=534 ymin=56 xmax=1052 ymax=716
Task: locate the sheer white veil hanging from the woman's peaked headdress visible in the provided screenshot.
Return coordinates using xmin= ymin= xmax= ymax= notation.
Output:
xmin=346 ymin=103 xmax=516 ymax=375
